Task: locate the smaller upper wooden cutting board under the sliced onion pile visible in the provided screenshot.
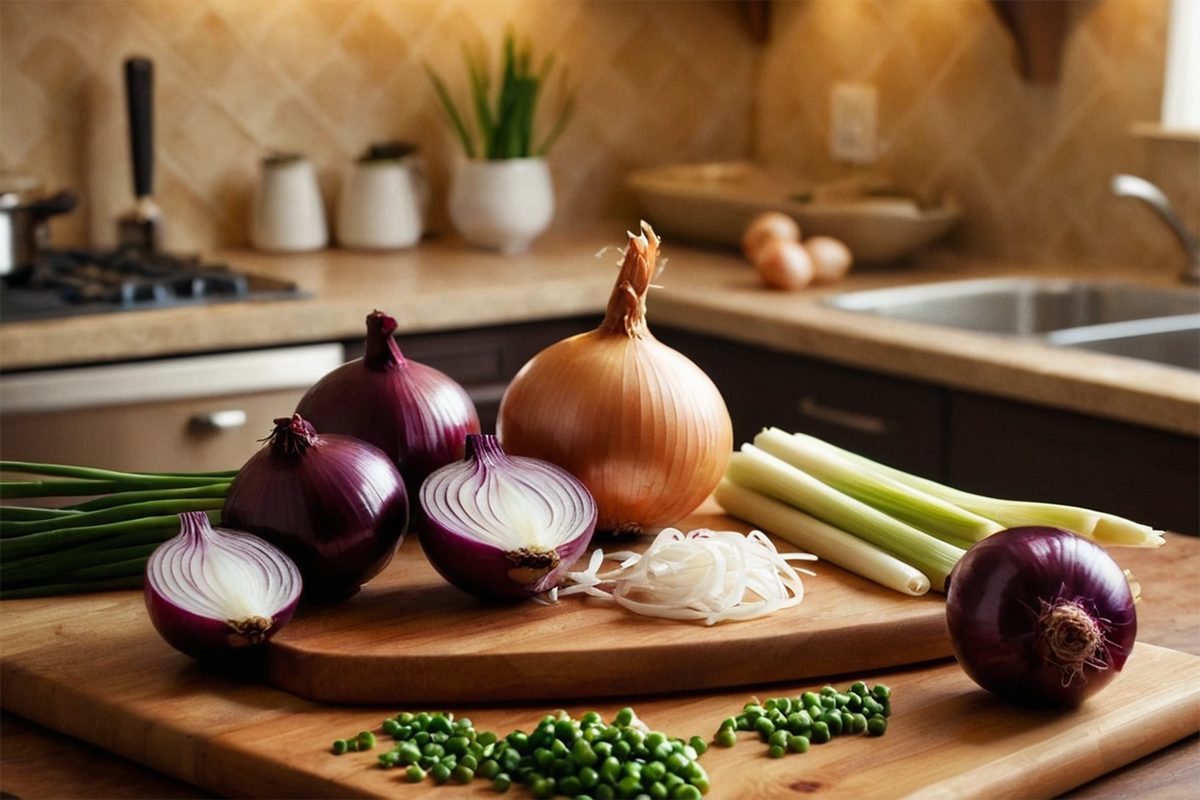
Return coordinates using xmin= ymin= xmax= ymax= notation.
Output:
xmin=268 ymin=513 xmax=952 ymax=703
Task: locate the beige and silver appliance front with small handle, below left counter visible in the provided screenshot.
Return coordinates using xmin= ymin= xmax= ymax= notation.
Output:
xmin=0 ymin=343 xmax=346 ymax=473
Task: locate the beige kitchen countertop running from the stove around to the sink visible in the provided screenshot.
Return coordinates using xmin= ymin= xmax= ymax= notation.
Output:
xmin=7 ymin=224 xmax=1200 ymax=435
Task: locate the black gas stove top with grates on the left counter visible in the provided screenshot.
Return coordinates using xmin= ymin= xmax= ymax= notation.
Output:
xmin=0 ymin=249 xmax=308 ymax=323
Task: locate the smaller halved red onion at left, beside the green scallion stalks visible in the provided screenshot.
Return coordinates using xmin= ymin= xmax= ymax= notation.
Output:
xmin=143 ymin=511 xmax=302 ymax=660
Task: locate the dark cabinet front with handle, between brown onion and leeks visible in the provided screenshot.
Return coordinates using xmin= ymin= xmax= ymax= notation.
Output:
xmin=655 ymin=329 xmax=946 ymax=479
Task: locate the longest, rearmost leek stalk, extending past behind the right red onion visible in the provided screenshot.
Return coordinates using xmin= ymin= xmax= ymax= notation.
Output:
xmin=791 ymin=433 xmax=1165 ymax=547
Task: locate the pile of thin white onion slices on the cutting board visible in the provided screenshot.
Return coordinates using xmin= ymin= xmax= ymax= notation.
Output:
xmin=558 ymin=528 xmax=816 ymax=625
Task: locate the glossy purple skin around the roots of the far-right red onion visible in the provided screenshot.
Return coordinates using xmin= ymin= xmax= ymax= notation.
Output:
xmin=946 ymin=527 xmax=1138 ymax=709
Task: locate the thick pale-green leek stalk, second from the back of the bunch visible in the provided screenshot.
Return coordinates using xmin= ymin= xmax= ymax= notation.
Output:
xmin=754 ymin=428 xmax=1004 ymax=546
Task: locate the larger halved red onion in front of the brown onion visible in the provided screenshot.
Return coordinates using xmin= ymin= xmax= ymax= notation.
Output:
xmin=419 ymin=434 xmax=596 ymax=600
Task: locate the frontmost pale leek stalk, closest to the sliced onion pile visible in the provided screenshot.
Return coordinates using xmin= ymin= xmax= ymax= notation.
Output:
xmin=713 ymin=479 xmax=929 ymax=597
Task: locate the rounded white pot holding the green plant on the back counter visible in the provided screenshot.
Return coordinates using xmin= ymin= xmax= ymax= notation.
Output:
xmin=449 ymin=158 xmax=554 ymax=253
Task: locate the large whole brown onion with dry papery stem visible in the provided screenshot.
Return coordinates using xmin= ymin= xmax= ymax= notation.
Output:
xmin=497 ymin=222 xmax=733 ymax=534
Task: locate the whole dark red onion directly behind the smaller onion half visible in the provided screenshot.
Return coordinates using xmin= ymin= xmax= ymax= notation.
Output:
xmin=221 ymin=414 xmax=408 ymax=600
